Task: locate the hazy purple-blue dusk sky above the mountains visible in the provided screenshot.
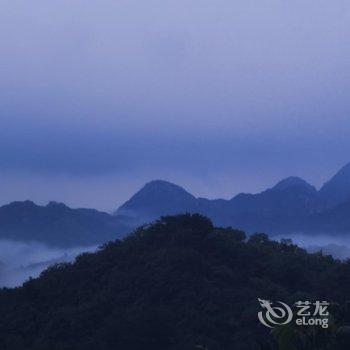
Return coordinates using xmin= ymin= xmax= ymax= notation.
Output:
xmin=0 ymin=0 xmax=350 ymax=211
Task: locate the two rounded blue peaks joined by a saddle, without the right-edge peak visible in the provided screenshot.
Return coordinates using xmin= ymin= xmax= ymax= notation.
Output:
xmin=116 ymin=177 xmax=319 ymax=232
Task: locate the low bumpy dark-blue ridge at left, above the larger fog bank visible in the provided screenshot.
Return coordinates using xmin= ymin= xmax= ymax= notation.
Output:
xmin=0 ymin=201 xmax=130 ymax=247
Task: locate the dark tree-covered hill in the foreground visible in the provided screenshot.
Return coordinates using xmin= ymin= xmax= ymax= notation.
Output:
xmin=0 ymin=215 xmax=350 ymax=350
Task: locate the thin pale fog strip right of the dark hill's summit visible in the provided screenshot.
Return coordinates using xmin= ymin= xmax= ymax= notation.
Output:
xmin=273 ymin=233 xmax=350 ymax=260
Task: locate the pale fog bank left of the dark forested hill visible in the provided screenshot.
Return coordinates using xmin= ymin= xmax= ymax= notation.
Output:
xmin=0 ymin=240 xmax=97 ymax=287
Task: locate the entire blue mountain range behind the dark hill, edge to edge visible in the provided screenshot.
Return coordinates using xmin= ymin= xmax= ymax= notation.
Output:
xmin=0 ymin=164 xmax=350 ymax=246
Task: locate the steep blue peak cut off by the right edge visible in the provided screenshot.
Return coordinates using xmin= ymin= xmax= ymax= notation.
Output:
xmin=320 ymin=163 xmax=350 ymax=207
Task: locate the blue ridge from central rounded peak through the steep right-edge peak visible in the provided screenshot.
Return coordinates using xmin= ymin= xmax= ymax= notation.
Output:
xmin=115 ymin=164 xmax=350 ymax=234
